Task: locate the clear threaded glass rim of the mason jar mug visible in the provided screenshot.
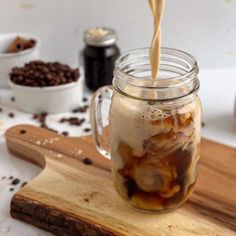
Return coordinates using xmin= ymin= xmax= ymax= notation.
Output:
xmin=113 ymin=47 xmax=199 ymax=101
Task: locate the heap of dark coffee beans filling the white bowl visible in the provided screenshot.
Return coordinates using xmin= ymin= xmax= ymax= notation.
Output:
xmin=10 ymin=60 xmax=80 ymax=87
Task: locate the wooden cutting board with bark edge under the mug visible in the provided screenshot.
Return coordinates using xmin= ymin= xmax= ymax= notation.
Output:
xmin=3 ymin=125 xmax=236 ymax=236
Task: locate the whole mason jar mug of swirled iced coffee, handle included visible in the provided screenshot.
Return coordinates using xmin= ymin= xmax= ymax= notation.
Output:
xmin=91 ymin=48 xmax=201 ymax=212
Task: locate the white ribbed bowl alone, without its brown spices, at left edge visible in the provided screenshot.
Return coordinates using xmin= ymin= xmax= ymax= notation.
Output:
xmin=0 ymin=33 xmax=40 ymax=88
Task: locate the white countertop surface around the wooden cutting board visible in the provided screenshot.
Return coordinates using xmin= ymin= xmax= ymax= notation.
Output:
xmin=0 ymin=69 xmax=236 ymax=236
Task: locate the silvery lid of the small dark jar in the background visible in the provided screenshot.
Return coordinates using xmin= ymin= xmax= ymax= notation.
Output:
xmin=84 ymin=27 xmax=117 ymax=47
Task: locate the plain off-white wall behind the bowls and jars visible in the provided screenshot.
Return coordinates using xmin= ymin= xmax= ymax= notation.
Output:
xmin=0 ymin=0 xmax=236 ymax=68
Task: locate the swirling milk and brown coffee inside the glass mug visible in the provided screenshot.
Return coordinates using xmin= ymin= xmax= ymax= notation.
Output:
xmin=111 ymin=91 xmax=201 ymax=211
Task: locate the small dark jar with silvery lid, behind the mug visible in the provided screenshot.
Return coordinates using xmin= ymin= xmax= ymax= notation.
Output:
xmin=83 ymin=28 xmax=120 ymax=90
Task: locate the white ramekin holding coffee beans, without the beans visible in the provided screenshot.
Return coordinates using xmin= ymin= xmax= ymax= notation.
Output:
xmin=10 ymin=76 xmax=83 ymax=113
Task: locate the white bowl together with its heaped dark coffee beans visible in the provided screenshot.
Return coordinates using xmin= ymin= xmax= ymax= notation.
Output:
xmin=10 ymin=61 xmax=83 ymax=113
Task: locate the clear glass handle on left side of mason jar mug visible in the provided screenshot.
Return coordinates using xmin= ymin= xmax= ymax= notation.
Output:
xmin=90 ymin=86 xmax=113 ymax=159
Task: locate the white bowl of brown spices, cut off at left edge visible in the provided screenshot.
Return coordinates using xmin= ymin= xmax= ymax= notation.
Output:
xmin=0 ymin=33 xmax=40 ymax=87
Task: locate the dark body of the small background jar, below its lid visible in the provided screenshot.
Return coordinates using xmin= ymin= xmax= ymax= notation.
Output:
xmin=84 ymin=45 xmax=120 ymax=90
